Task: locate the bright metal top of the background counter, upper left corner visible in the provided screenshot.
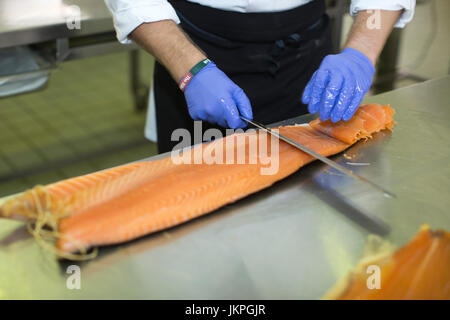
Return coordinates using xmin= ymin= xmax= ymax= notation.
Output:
xmin=0 ymin=0 xmax=114 ymax=48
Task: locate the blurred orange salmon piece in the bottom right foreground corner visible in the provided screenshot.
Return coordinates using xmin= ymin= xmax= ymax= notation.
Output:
xmin=325 ymin=225 xmax=450 ymax=300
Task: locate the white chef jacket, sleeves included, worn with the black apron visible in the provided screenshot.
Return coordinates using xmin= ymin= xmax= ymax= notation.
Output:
xmin=105 ymin=0 xmax=416 ymax=141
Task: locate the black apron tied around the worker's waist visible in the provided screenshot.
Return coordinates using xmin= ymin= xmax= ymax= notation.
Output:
xmin=154 ymin=0 xmax=332 ymax=153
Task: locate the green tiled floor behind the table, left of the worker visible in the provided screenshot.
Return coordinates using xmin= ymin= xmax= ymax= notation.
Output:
xmin=0 ymin=52 xmax=156 ymax=196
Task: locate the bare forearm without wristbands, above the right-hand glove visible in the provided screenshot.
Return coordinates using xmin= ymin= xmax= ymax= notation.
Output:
xmin=345 ymin=10 xmax=402 ymax=65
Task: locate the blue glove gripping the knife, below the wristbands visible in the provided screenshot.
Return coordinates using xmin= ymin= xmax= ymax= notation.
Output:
xmin=184 ymin=62 xmax=253 ymax=129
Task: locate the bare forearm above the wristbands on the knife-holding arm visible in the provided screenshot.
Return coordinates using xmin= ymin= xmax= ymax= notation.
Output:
xmin=129 ymin=20 xmax=206 ymax=81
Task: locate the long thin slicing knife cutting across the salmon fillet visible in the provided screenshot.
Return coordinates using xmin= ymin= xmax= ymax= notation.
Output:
xmin=240 ymin=116 xmax=396 ymax=198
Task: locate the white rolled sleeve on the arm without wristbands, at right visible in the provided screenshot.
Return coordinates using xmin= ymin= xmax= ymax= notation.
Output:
xmin=350 ymin=0 xmax=416 ymax=28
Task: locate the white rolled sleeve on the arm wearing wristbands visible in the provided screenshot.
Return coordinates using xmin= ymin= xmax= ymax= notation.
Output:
xmin=105 ymin=0 xmax=180 ymax=43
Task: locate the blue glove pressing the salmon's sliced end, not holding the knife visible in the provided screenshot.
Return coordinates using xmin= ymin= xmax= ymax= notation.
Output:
xmin=302 ymin=48 xmax=375 ymax=122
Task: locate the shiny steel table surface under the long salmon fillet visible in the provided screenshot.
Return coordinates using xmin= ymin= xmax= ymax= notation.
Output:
xmin=0 ymin=77 xmax=450 ymax=299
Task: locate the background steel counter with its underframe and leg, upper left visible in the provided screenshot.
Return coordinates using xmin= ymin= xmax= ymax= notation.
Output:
xmin=0 ymin=0 xmax=148 ymax=110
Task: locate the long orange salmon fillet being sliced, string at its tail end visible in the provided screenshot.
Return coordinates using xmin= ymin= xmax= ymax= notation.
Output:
xmin=0 ymin=104 xmax=394 ymax=252
